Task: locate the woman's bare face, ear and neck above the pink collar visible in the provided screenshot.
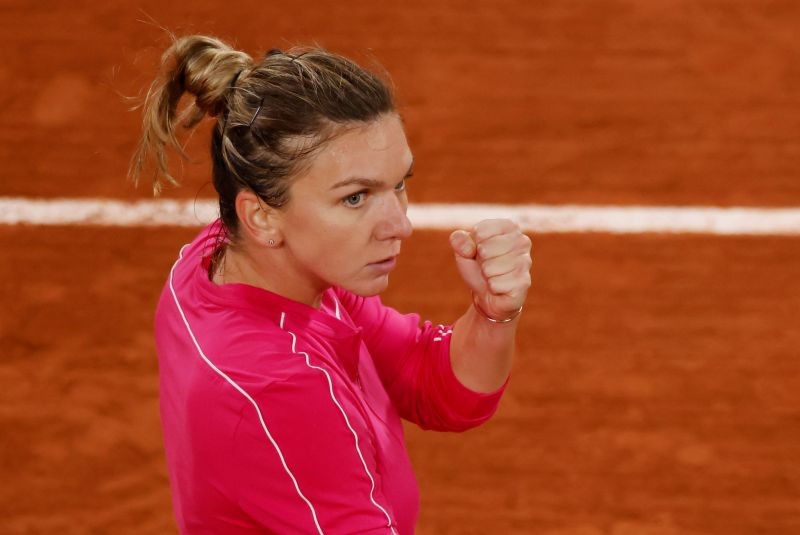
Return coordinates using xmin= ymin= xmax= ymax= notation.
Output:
xmin=216 ymin=115 xmax=413 ymax=308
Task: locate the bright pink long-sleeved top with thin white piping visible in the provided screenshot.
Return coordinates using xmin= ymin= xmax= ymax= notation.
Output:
xmin=155 ymin=222 xmax=505 ymax=535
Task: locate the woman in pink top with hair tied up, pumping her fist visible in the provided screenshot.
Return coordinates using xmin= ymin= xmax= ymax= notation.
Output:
xmin=132 ymin=36 xmax=531 ymax=534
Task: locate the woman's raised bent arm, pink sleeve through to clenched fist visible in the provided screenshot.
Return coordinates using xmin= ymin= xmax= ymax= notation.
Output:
xmin=336 ymin=224 xmax=531 ymax=431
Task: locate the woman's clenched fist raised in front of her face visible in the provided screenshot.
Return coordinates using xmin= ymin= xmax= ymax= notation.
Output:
xmin=450 ymin=219 xmax=533 ymax=320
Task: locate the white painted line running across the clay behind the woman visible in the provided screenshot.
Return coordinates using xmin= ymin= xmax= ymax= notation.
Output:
xmin=0 ymin=197 xmax=800 ymax=236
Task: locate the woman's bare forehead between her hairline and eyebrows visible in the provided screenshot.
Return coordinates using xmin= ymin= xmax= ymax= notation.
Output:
xmin=297 ymin=114 xmax=413 ymax=187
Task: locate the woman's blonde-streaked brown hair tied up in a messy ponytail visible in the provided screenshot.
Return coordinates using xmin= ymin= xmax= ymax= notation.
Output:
xmin=129 ymin=35 xmax=395 ymax=235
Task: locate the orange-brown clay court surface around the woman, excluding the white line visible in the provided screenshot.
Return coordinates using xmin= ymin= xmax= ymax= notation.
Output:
xmin=0 ymin=0 xmax=800 ymax=535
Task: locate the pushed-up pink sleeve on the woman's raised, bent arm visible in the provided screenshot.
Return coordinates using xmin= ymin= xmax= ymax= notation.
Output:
xmin=336 ymin=289 xmax=508 ymax=431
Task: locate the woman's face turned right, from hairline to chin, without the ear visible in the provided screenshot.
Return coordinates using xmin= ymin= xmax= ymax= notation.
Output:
xmin=281 ymin=114 xmax=413 ymax=296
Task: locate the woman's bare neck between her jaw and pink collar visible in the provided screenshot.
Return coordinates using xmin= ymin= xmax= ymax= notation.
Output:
xmin=213 ymin=245 xmax=326 ymax=309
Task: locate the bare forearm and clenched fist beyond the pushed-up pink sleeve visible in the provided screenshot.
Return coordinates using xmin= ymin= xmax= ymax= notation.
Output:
xmin=450 ymin=219 xmax=531 ymax=392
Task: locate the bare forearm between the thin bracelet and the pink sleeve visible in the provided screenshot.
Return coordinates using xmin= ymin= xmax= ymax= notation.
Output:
xmin=450 ymin=305 xmax=519 ymax=393
